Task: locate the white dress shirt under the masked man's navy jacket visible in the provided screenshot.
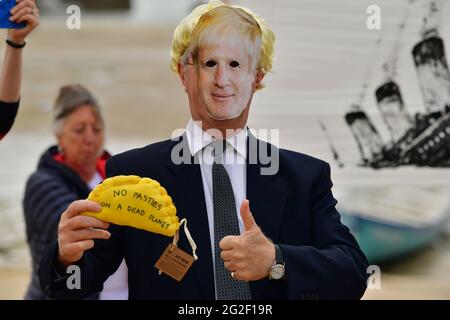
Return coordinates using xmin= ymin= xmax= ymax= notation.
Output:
xmin=186 ymin=119 xmax=247 ymax=279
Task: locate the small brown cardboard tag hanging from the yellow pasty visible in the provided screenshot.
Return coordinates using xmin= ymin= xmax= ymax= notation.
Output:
xmin=155 ymin=243 xmax=194 ymax=282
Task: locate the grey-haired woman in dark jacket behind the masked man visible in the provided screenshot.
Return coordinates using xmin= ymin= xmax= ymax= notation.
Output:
xmin=23 ymin=85 xmax=128 ymax=299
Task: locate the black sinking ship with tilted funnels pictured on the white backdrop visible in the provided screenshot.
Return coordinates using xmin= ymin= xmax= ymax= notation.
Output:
xmin=345 ymin=29 xmax=450 ymax=168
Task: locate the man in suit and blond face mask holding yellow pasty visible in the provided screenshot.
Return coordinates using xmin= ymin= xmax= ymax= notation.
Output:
xmin=40 ymin=1 xmax=367 ymax=300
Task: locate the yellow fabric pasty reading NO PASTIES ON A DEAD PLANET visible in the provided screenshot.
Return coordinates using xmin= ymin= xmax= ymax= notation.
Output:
xmin=82 ymin=176 xmax=180 ymax=237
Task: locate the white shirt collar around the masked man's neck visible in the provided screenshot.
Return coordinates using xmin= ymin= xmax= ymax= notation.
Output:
xmin=186 ymin=119 xmax=248 ymax=159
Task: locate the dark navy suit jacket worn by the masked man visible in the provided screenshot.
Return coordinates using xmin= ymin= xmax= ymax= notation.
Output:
xmin=40 ymin=135 xmax=367 ymax=299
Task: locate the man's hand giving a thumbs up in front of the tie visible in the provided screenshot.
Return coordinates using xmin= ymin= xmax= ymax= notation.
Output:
xmin=219 ymin=199 xmax=275 ymax=281
